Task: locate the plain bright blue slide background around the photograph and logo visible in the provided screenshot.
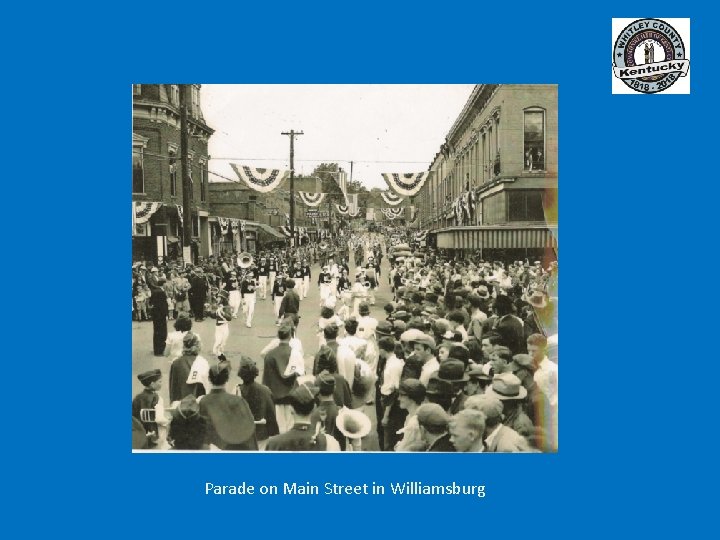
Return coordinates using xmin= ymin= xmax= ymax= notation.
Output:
xmin=5 ymin=1 xmax=719 ymax=538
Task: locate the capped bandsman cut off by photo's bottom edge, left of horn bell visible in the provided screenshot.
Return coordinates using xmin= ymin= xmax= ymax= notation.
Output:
xmin=267 ymin=384 xmax=340 ymax=452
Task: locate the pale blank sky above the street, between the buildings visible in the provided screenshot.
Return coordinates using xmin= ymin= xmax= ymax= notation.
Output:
xmin=200 ymin=84 xmax=473 ymax=189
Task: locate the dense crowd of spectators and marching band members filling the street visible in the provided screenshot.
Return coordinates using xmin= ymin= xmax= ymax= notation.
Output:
xmin=132 ymin=234 xmax=558 ymax=452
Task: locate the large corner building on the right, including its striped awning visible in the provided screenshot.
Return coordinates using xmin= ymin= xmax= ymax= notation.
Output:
xmin=413 ymin=84 xmax=558 ymax=260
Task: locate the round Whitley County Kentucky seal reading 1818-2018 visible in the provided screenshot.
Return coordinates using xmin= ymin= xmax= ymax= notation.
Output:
xmin=613 ymin=19 xmax=687 ymax=94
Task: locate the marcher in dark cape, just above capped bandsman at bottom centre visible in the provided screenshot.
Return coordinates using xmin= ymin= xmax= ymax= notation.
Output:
xmin=262 ymin=325 xmax=297 ymax=433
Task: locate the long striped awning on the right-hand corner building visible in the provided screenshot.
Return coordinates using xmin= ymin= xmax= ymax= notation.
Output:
xmin=437 ymin=226 xmax=558 ymax=250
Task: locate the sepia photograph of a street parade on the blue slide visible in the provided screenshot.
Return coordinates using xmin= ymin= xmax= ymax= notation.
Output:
xmin=129 ymin=84 xmax=559 ymax=453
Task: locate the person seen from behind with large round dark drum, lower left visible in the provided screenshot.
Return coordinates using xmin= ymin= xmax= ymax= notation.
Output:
xmin=200 ymin=363 xmax=258 ymax=450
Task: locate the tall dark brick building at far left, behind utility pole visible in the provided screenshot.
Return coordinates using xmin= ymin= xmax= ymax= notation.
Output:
xmin=132 ymin=84 xmax=214 ymax=260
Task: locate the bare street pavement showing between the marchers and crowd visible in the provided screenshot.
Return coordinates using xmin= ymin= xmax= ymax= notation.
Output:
xmin=131 ymin=258 xmax=392 ymax=451
